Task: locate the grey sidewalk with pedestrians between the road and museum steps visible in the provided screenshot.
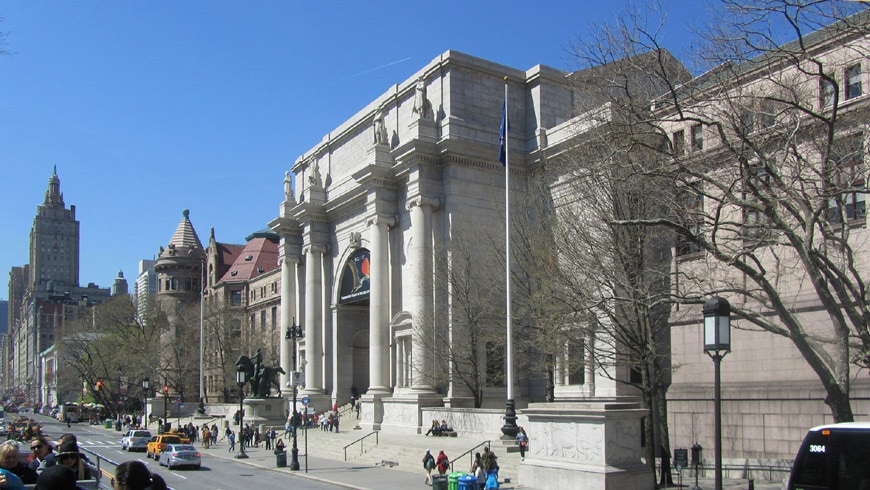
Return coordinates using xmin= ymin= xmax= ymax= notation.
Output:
xmin=107 ymin=419 xmax=784 ymax=490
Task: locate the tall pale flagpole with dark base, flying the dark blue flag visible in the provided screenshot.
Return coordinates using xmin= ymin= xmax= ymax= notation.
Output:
xmin=501 ymin=77 xmax=518 ymax=438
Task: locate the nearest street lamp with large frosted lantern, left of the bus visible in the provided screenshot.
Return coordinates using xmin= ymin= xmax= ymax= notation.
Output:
xmin=703 ymin=296 xmax=731 ymax=490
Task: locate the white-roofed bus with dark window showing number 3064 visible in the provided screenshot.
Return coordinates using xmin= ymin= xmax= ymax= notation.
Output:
xmin=788 ymin=422 xmax=870 ymax=490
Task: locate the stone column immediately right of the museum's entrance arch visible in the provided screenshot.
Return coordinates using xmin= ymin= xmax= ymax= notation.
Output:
xmin=367 ymin=216 xmax=396 ymax=395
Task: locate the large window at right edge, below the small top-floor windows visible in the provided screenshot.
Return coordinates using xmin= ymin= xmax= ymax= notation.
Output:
xmin=828 ymin=134 xmax=867 ymax=223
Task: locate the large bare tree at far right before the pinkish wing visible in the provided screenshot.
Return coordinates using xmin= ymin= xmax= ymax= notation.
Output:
xmin=578 ymin=0 xmax=870 ymax=421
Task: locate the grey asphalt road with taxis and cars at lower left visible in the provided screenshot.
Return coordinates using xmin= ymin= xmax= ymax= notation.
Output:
xmin=20 ymin=415 xmax=340 ymax=490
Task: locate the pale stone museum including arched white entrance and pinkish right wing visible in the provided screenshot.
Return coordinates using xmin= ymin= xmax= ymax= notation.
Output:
xmin=270 ymin=7 xmax=870 ymax=468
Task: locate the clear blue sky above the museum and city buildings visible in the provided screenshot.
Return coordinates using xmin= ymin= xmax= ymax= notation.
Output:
xmin=0 ymin=0 xmax=702 ymax=298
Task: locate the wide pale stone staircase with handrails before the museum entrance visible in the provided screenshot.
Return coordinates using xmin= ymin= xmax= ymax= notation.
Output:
xmin=296 ymin=424 xmax=520 ymax=482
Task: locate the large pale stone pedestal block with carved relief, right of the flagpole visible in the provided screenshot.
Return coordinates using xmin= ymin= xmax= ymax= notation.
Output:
xmin=518 ymin=400 xmax=655 ymax=490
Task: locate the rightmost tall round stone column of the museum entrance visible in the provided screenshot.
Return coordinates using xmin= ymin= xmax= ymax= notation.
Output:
xmin=406 ymin=196 xmax=439 ymax=392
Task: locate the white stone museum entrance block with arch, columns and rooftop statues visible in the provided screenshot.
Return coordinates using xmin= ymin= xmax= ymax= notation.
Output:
xmin=270 ymin=51 xmax=640 ymax=433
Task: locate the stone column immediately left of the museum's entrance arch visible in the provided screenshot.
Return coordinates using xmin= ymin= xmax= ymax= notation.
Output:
xmin=304 ymin=245 xmax=326 ymax=395
